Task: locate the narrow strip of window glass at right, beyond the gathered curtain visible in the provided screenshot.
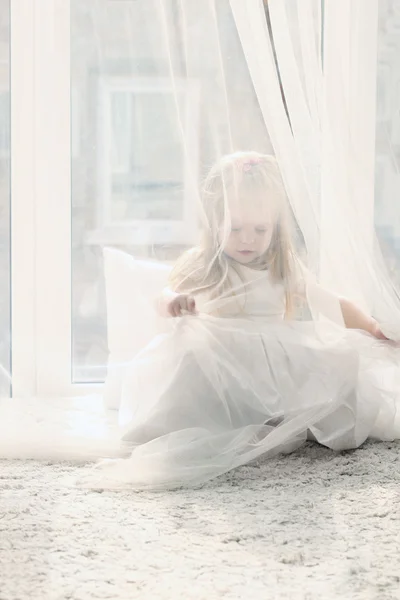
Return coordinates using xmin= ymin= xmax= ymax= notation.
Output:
xmin=375 ymin=0 xmax=400 ymax=286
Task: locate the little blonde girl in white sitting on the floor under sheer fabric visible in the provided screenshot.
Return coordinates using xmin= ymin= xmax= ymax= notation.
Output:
xmin=104 ymin=152 xmax=400 ymax=488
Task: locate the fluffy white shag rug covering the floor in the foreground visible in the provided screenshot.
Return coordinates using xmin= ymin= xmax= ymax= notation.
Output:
xmin=0 ymin=443 xmax=400 ymax=600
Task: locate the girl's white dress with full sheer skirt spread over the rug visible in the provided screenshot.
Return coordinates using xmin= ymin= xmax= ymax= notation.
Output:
xmin=87 ymin=267 xmax=400 ymax=489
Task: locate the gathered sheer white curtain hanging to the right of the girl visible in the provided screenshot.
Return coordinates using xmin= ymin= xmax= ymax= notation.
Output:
xmin=231 ymin=0 xmax=400 ymax=336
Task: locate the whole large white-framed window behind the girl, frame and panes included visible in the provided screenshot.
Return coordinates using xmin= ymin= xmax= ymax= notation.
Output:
xmin=5 ymin=0 xmax=400 ymax=396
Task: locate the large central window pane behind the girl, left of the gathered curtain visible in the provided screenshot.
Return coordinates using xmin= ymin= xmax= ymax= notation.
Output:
xmin=71 ymin=0 xmax=272 ymax=382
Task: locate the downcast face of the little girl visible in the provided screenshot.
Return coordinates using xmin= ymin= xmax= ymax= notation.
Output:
xmin=219 ymin=203 xmax=275 ymax=265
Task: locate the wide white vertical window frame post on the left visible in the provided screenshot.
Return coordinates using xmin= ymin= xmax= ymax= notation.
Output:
xmin=11 ymin=0 xmax=377 ymax=397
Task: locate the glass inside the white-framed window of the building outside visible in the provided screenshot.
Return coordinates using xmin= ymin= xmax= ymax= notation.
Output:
xmin=108 ymin=89 xmax=184 ymax=223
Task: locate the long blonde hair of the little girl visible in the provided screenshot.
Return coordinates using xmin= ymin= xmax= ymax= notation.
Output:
xmin=170 ymin=152 xmax=294 ymax=317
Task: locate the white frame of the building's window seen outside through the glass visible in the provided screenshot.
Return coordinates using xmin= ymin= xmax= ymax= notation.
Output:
xmin=87 ymin=76 xmax=199 ymax=246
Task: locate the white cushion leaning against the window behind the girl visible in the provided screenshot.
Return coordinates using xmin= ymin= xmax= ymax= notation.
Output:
xmin=104 ymin=248 xmax=171 ymax=409
